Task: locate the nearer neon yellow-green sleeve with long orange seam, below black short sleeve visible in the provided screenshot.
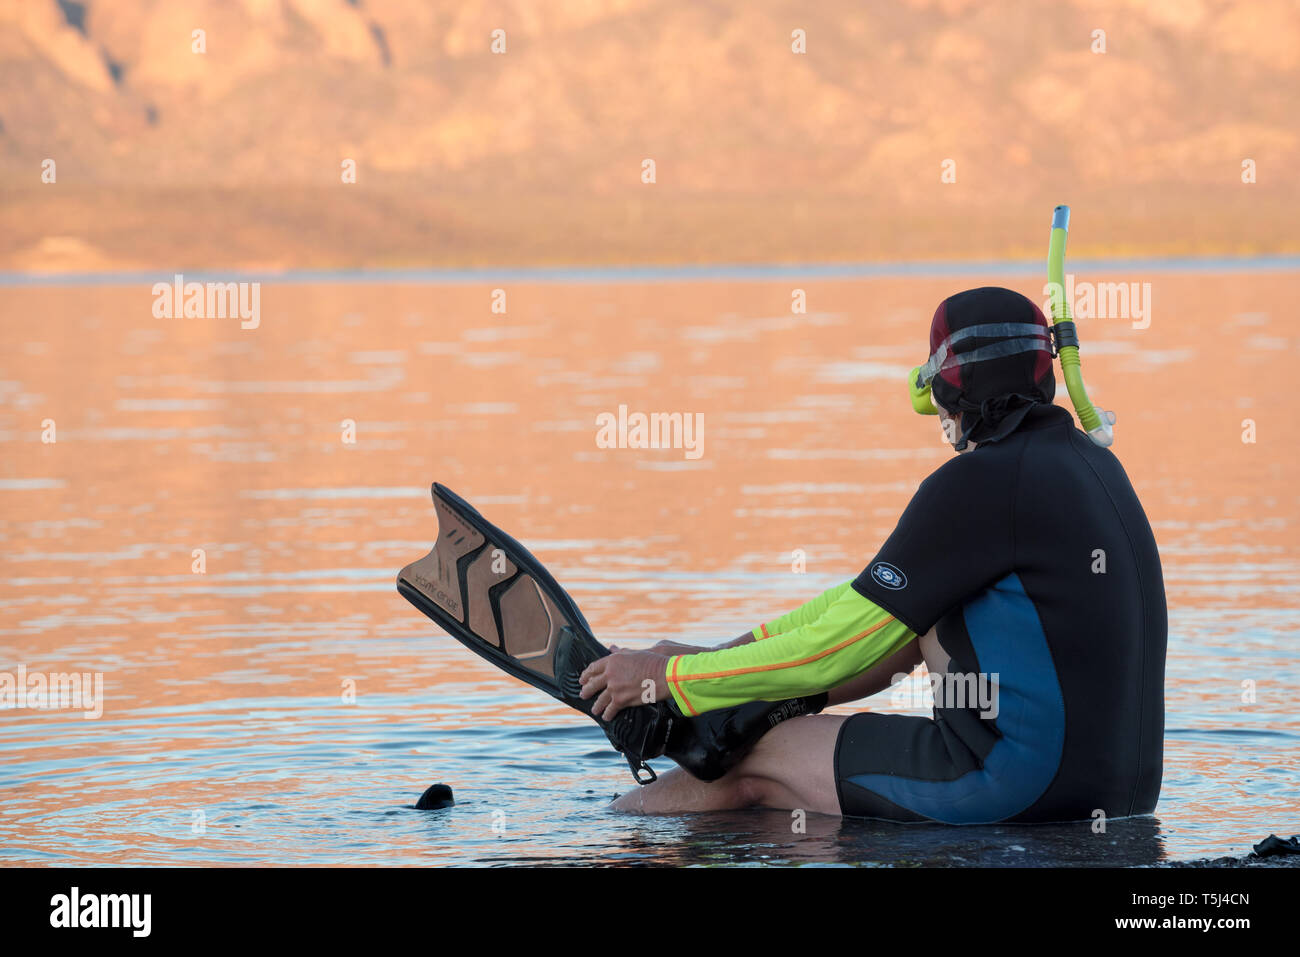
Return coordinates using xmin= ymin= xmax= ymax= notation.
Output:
xmin=667 ymin=588 xmax=917 ymax=715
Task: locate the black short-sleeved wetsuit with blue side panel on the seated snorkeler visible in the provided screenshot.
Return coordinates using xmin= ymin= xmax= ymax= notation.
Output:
xmin=835 ymin=406 xmax=1167 ymax=823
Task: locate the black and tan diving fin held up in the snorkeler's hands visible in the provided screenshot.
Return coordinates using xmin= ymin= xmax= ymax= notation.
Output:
xmin=398 ymin=482 xmax=675 ymax=784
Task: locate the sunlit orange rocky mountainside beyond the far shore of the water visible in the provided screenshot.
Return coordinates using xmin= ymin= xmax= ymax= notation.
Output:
xmin=0 ymin=0 xmax=1300 ymax=269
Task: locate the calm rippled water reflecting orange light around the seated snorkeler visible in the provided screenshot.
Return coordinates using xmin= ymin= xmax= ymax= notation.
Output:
xmin=0 ymin=270 xmax=1300 ymax=865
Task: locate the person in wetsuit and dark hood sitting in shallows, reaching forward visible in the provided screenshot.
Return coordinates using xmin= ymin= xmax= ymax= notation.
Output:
xmin=582 ymin=287 xmax=1166 ymax=824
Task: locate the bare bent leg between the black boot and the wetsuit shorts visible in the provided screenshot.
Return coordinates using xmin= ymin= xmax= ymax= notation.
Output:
xmin=611 ymin=714 xmax=845 ymax=815
